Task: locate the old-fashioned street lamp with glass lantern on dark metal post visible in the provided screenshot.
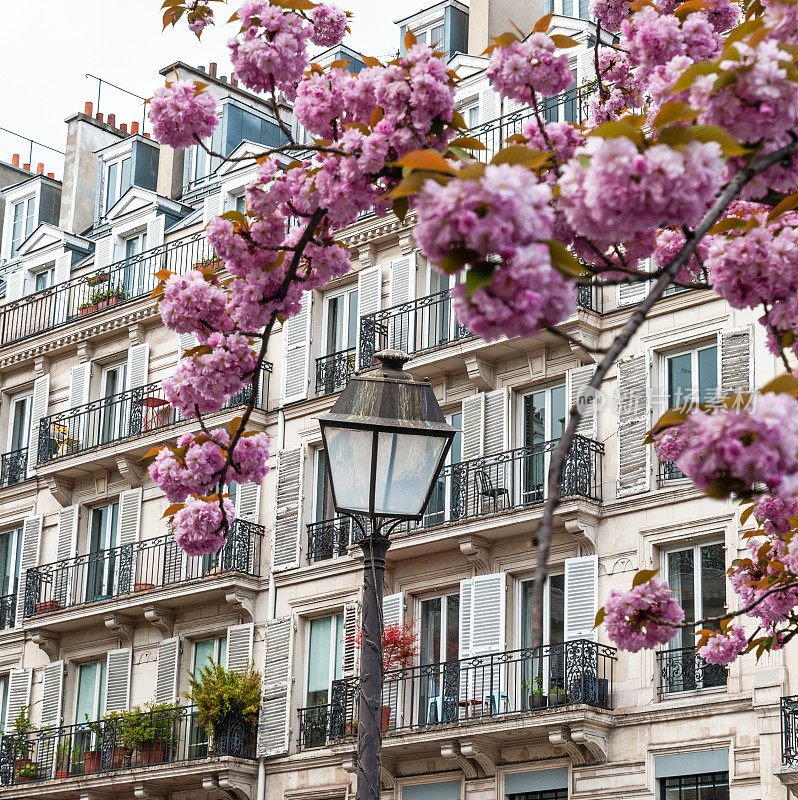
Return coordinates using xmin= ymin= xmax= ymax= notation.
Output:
xmin=319 ymin=350 xmax=455 ymax=800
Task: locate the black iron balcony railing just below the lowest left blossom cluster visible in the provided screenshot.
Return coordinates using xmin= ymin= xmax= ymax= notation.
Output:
xmin=24 ymin=519 xmax=264 ymax=619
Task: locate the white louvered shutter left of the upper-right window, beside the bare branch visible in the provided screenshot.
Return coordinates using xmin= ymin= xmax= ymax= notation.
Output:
xmin=618 ymin=353 xmax=651 ymax=496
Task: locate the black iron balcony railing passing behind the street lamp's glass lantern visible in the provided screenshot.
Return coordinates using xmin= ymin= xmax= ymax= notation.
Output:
xmin=307 ymin=436 xmax=604 ymax=563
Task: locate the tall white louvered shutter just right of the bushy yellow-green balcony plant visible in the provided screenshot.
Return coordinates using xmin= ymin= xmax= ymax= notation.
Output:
xmin=258 ymin=617 xmax=292 ymax=757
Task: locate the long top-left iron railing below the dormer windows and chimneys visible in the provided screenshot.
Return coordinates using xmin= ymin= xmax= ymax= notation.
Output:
xmin=0 ymin=231 xmax=221 ymax=345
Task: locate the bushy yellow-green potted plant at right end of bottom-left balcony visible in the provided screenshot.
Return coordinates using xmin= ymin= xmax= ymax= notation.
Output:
xmin=186 ymin=661 xmax=260 ymax=756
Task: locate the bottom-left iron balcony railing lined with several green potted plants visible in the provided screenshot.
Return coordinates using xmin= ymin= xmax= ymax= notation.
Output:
xmin=0 ymin=706 xmax=255 ymax=786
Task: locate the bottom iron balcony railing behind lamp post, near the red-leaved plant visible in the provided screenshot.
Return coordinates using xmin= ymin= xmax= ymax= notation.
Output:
xmin=299 ymin=639 xmax=616 ymax=749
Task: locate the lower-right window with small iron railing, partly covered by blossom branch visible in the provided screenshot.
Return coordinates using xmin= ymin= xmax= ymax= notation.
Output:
xmin=660 ymin=543 xmax=726 ymax=692
